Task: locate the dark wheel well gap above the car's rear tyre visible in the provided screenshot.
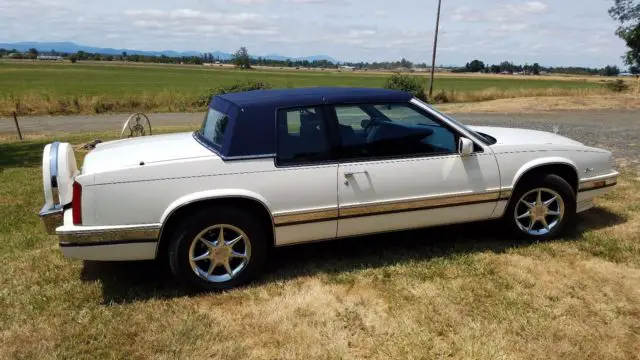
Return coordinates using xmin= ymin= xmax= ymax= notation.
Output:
xmin=156 ymin=197 xmax=275 ymax=258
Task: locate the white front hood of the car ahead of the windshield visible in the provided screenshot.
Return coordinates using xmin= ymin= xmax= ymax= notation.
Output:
xmin=469 ymin=126 xmax=583 ymax=145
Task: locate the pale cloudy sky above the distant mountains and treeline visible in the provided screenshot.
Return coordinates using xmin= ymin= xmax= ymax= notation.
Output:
xmin=0 ymin=0 xmax=626 ymax=66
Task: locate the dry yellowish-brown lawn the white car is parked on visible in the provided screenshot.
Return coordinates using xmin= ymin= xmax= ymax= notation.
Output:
xmin=0 ymin=134 xmax=640 ymax=359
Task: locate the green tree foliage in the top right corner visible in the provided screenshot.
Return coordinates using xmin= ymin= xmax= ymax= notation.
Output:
xmin=609 ymin=0 xmax=640 ymax=70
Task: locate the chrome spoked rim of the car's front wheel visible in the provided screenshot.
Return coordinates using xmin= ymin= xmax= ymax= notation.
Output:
xmin=514 ymin=188 xmax=565 ymax=236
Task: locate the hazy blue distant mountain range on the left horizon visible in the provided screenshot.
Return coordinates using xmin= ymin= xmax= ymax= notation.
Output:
xmin=0 ymin=41 xmax=338 ymax=63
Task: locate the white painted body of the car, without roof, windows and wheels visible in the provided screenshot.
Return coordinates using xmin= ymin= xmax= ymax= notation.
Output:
xmin=43 ymin=95 xmax=618 ymax=261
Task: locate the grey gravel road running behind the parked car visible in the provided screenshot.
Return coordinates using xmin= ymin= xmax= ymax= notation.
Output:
xmin=0 ymin=111 xmax=640 ymax=170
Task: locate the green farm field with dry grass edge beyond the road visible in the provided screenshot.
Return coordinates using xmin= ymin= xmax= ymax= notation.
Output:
xmin=0 ymin=62 xmax=605 ymax=116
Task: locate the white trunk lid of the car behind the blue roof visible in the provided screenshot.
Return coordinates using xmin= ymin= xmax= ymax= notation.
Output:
xmin=82 ymin=133 xmax=216 ymax=174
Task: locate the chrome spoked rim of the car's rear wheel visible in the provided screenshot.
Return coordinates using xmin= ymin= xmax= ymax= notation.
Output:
xmin=189 ymin=224 xmax=251 ymax=283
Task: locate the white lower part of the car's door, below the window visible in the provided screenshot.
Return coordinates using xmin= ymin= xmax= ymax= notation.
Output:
xmin=338 ymin=150 xmax=500 ymax=237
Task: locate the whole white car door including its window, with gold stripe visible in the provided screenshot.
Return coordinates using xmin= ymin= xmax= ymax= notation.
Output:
xmin=331 ymin=104 xmax=500 ymax=237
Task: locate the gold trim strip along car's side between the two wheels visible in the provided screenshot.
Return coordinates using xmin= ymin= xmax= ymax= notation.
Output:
xmin=274 ymin=190 xmax=512 ymax=226
